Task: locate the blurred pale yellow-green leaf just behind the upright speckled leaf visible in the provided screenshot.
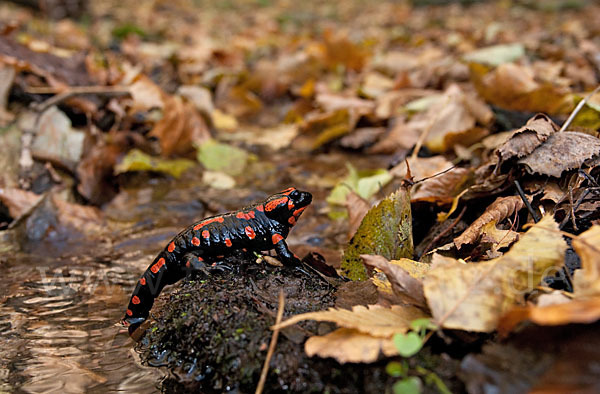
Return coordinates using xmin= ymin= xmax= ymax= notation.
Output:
xmin=326 ymin=163 xmax=392 ymax=205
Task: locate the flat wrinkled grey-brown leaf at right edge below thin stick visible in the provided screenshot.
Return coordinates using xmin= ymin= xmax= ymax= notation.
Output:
xmin=519 ymin=131 xmax=600 ymax=178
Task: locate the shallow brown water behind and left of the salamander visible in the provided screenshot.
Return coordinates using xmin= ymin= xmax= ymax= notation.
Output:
xmin=0 ymin=151 xmax=384 ymax=393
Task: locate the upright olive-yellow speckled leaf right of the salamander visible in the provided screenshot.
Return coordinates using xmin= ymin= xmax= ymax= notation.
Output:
xmin=341 ymin=188 xmax=413 ymax=280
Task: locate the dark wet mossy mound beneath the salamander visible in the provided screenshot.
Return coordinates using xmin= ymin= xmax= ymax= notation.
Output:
xmin=136 ymin=260 xmax=460 ymax=393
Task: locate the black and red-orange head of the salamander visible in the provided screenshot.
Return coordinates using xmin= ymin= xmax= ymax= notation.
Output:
xmin=264 ymin=187 xmax=312 ymax=226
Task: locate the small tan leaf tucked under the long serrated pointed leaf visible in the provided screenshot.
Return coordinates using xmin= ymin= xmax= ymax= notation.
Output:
xmin=304 ymin=328 xmax=398 ymax=364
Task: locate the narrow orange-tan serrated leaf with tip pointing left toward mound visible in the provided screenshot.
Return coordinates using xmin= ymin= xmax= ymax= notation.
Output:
xmin=271 ymin=305 xmax=427 ymax=338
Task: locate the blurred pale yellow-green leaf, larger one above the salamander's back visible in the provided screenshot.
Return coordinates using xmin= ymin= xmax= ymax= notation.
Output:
xmin=198 ymin=139 xmax=256 ymax=176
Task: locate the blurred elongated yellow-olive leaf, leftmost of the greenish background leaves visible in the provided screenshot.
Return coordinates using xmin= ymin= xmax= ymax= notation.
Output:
xmin=115 ymin=149 xmax=196 ymax=178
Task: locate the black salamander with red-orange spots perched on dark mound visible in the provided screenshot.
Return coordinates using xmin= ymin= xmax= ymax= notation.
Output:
xmin=122 ymin=187 xmax=312 ymax=335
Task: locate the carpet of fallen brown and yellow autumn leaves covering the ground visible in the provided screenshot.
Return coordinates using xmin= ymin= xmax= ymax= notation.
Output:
xmin=0 ymin=1 xmax=600 ymax=392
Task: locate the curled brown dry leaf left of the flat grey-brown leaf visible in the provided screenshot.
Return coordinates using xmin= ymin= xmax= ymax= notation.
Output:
xmin=496 ymin=114 xmax=558 ymax=161
